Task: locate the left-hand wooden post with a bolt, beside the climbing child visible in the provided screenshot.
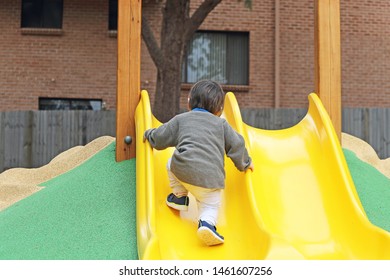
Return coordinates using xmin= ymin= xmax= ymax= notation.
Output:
xmin=116 ymin=0 xmax=142 ymax=162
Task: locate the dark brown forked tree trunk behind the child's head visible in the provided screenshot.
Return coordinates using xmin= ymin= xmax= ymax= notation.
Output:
xmin=142 ymin=0 xmax=222 ymax=122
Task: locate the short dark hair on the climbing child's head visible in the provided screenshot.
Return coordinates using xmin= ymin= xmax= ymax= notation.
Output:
xmin=188 ymin=80 xmax=225 ymax=114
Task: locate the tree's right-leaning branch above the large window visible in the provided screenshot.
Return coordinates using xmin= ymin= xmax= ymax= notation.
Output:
xmin=184 ymin=0 xmax=222 ymax=42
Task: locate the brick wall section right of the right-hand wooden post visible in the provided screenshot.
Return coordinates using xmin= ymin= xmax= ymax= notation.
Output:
xmin=341 ymin=0 xmax=390 ymax=107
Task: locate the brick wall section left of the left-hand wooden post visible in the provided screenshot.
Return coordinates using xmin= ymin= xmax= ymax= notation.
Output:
xmin=0 ymin=0 xmax=117 ymax=110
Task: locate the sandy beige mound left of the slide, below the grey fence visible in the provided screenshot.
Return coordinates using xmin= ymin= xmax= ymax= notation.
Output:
xmin=0 ymin=136 xmax=115 ymax=211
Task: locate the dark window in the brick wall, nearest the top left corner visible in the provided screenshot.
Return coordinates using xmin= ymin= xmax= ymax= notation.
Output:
xmin=21 ymin=0 xmax=63 ymax=29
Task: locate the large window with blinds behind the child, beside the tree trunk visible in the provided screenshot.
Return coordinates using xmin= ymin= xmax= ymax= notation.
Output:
xmin=183 ymin=31 xmax=249 ymax=85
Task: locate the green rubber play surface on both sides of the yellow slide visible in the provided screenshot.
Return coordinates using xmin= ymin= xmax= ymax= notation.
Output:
xmin=0 ymin=143 xmax=390 ymax=260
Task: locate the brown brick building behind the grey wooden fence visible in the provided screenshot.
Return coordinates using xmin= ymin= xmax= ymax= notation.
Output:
xmin=0 ymin=0 xmax=390 ymax=111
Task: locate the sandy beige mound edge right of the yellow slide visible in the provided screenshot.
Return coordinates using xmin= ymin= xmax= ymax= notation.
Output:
xmin=341 ymin=133 xmax=390 ymax=178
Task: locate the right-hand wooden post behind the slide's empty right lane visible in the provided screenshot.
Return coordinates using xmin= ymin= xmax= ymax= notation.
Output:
xmin=315 ymin=0 xmax=341 ymax=141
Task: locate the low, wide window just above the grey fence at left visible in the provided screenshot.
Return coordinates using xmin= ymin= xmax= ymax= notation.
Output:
xmin=39 ymin=97 xmax=102 ymax=111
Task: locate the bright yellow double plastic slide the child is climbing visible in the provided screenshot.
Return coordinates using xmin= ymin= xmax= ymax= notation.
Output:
xmin=135 ymin=91 xmax=390 ymax=260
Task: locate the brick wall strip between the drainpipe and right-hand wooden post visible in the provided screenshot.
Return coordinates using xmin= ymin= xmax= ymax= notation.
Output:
xmin=280 ymin=0 xmax=315 ymax=107
